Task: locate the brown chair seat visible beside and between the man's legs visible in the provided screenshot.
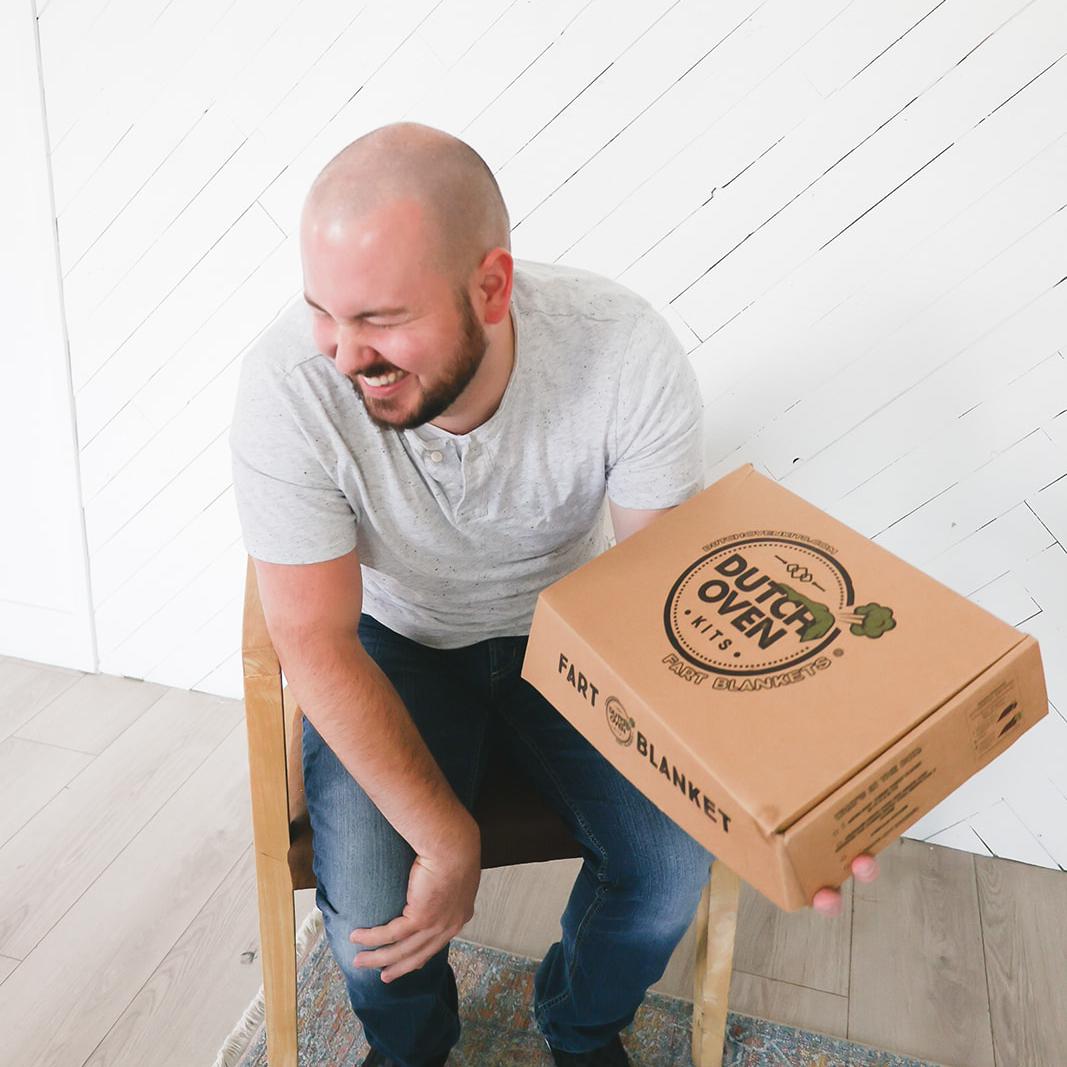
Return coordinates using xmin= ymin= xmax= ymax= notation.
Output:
xmin=283 ymin=686 xmax=583 ymax=889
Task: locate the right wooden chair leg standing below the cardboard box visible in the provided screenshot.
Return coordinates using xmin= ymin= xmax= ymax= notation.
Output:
xmin=692 ymin=859 xmax=740 ymax=1067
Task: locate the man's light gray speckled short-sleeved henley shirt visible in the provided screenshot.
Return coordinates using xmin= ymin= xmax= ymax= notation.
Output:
xmin=229 ymin=259 xmax=704 ymax=649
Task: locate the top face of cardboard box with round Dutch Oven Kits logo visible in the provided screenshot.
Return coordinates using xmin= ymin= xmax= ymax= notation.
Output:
xmin=541 ymin=464 xmax=1024 ymax=834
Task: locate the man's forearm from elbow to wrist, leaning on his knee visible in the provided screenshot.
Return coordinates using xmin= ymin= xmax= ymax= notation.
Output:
xmin=282 ymin=637 xmax=478 ymax=856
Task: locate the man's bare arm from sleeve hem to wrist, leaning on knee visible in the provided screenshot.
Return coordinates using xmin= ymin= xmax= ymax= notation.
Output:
xmin=255 ymin=550 xmax=480 ymax=857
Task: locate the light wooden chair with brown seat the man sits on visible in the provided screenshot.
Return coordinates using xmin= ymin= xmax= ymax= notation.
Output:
xmin=242 ymin=557 xmax=739 ymax=1067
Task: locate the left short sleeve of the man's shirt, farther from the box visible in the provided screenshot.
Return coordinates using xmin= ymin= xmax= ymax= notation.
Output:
xmin=229 ymin=349 xmax=357 ymax=563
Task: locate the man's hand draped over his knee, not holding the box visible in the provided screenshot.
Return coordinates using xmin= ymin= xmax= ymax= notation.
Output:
xmin=349 ymin=818 xmax=481 ymax=982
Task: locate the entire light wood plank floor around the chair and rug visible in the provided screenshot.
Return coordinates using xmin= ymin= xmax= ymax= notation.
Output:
xmin=0 ymin=657 xmax=1067 ymax=1067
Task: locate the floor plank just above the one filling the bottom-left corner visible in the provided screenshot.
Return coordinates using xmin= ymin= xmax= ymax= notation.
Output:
xmin=0 ymin=682 xmax=248 ymax=959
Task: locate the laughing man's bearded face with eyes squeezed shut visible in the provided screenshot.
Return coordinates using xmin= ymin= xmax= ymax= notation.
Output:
xmin=301 ymin=202 xmax=489 ymax=430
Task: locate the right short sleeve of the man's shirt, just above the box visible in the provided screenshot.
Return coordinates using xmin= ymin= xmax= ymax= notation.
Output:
xmin=606 ymin=307 xmax=704 ymax=509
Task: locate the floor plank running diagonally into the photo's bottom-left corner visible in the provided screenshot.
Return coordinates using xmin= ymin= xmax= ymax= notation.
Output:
xmin=0 ymin=717 xmax=251 ymax=1067
